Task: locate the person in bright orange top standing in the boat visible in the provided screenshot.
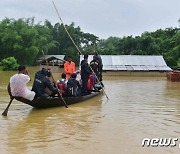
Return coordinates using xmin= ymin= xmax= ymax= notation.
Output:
xmin=64 ymin=56 xmax=75 ymax=79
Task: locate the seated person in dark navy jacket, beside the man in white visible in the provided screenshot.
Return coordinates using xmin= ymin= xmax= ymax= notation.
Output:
xmin=32 ymin=68 xmax=58 ymax=97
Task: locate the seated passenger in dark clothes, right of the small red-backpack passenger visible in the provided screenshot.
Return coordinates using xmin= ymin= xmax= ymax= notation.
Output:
xmin=66 ymin=73 xmax=81 ymax=96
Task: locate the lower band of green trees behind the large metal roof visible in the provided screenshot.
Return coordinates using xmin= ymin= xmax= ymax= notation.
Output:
xmin=97 ymin=28 xmax=180 ymax=67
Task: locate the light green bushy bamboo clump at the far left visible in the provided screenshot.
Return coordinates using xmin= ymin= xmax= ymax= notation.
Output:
xmin=0 ymin=18 xmax=57 ymax=65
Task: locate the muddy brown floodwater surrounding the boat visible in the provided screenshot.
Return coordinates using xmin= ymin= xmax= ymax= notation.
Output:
xmin=0 ymin=69 xmax=180 ymax=154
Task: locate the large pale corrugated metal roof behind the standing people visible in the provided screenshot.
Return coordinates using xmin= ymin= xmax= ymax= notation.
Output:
xmin=80 ymin=55 xmax=172 ymax=71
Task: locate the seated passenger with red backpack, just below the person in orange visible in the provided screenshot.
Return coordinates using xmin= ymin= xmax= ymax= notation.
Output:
xmin=57 ymin=73 xmax=67 ymax=96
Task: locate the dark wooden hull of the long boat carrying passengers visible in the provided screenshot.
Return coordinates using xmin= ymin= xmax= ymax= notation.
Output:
xmin=14 ymin=90 xmax=103 ymax=108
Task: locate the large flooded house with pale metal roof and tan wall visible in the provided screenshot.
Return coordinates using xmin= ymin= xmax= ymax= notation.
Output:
xmin=80 ymin=55 xmax=172 ymax=76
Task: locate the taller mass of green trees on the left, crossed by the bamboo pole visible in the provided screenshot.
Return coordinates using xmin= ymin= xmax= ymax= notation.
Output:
xmin=0 ymin=18 xmax=98 ymax=65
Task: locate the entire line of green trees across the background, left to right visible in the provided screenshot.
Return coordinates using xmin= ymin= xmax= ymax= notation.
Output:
xmin=0 ymin=18 xmax=180 ymax=67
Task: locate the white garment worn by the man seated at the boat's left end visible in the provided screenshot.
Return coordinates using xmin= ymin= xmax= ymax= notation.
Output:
xmin=10 ymin=73 xmax=35 ymax=101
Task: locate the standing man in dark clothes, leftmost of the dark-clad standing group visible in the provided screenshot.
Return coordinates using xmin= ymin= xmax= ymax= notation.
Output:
xmin=81 ymin=54 xmax=92 ymax=95
